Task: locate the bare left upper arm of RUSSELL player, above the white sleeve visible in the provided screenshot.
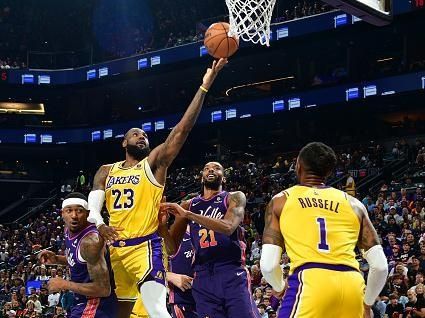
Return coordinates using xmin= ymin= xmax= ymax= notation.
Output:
xmin=263 ymin=193 xmax=286 ymax=249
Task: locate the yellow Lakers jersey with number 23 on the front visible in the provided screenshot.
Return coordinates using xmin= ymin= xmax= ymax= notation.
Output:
xmin=105 ymin=158 xmax=164 ymax=239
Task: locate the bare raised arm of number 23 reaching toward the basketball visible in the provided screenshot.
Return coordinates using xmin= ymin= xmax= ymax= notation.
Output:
xmin=148 ymin=59 xmax=227 ymax=184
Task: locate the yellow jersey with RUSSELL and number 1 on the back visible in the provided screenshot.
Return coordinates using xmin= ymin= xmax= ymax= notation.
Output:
xmin=280 ymin=186 xmax=360 ymax=272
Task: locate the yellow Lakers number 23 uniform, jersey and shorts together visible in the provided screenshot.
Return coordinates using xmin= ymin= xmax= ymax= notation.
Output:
xmin=105 ymin=158 xmax=165 ymax=301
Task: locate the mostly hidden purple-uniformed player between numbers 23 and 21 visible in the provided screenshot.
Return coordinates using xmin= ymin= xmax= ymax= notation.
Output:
xmin=167 ymin=231 xmax=198 ymax=318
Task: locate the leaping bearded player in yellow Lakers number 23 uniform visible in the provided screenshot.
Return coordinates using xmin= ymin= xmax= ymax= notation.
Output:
xmin=88 ymin=59 xmax=227 ymax=318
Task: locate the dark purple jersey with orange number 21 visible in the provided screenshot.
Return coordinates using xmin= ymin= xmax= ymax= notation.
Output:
xmin=189 ymin=191 xmax=246 ymax=271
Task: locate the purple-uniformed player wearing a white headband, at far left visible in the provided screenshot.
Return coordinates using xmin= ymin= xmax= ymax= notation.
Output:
xmin=39 ymin=193 xmax=118 ymax=318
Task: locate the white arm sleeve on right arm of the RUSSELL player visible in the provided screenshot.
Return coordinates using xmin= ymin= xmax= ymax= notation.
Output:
xmin=364 ymin=245 xmax=388 ymax=306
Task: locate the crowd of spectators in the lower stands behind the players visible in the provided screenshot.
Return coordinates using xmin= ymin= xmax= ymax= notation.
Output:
xmin=0 ymin=139 xmax=425 ymax=318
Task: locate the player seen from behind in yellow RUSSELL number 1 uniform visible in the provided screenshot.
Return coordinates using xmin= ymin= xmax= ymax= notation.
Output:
xmin=260 ymin=142 xmax=388 ymax=318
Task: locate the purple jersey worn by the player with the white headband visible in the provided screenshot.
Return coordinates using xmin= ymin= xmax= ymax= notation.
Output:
xmin=65 ymin=224 xmax=115 ymax=303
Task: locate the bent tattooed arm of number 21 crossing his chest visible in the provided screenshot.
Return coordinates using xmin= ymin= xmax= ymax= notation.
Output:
xmin=187 ymin=191 xmax=246 ymax=236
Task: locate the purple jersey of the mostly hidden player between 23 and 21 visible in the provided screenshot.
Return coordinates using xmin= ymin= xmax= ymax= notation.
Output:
xmin=168 ymin=232 xmax=195 ymax=305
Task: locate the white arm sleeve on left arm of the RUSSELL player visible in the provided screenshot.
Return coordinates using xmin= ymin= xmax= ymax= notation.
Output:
xmin=260 ymin=244 xmax=285 ymax=292
